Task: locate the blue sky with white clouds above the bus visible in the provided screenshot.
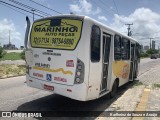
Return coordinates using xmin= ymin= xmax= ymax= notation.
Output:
xmin=0 ymin=0 xmax=160 ymax=48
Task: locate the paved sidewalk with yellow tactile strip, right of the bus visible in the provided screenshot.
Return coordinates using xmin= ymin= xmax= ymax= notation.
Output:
xmin=96 ymin=64 xmax=160 ymax=120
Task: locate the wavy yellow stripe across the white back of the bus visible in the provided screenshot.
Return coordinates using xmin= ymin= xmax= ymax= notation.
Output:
xmin=33 ymin=66 xmax=73 ymax=75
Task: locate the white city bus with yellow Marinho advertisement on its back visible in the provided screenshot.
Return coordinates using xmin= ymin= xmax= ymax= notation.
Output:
xmin=25 ymin=15 xmax=140 ymax=101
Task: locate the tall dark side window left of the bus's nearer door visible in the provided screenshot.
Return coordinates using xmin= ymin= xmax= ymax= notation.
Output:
xmin=91 ymin=25 xmax=101 ymax=62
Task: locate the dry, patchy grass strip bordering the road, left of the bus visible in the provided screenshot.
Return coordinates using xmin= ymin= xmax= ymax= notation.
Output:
xmin=0 ymin=64 xmax=26 ymax=78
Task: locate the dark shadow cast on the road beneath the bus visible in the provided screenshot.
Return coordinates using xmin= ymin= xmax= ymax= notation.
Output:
xmin=16 ymin=81 xmax=138 ymax=120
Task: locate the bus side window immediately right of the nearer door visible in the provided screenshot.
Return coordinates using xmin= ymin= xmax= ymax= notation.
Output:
xmin=114 ymin=35 xmax=121 ymax=60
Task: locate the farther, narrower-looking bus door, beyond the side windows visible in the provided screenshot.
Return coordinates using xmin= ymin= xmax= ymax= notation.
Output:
xmin=129 ymin=43 xmax=135 ymax=81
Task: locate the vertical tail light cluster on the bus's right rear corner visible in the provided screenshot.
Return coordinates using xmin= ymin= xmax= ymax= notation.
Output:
xmin=74 ymin=59 xmax=84 ymax=84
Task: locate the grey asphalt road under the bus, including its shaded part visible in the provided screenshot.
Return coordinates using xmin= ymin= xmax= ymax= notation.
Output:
xmin=0 ymin=58 xmax=160 ymax=119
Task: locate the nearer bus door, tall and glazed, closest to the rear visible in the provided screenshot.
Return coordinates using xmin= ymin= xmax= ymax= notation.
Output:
xmin=100 ymin=33 xmax=111 ymax=94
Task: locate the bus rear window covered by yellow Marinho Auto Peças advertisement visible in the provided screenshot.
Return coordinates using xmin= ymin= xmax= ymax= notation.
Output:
xmin=30 ymin=17 xmax=83 ymax=50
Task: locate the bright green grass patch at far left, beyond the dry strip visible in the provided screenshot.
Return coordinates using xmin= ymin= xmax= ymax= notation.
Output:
xmin=0 ymin=52 xmax=22 ymax=60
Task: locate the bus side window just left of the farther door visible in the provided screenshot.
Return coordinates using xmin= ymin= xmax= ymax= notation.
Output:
xmin=121 ymin=38 xmax=130 ymax=60
